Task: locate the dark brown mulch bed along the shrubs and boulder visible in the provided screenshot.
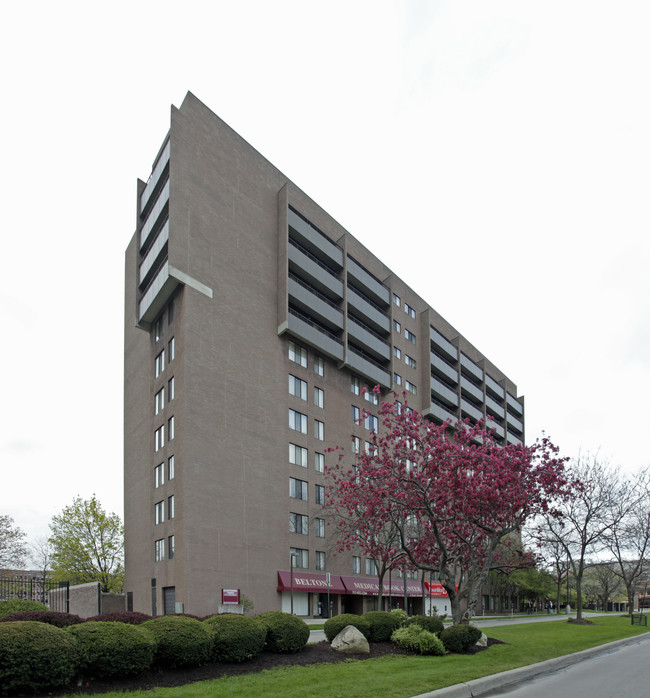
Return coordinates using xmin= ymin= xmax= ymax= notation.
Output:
xmin=47 ymin=638 xmax=501 ymax=696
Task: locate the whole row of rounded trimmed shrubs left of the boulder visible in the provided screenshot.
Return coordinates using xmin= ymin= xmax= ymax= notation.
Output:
xmin=0 ymin=610 xmax=309 ymax=694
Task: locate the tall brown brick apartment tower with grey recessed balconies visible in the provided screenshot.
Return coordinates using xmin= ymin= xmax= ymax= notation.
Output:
xmin=124 ymin=93 xmax=524 ymax=615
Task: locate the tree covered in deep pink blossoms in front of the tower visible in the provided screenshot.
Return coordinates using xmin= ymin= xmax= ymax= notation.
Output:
xmin=328 ymin=388 xmax=570 ymax=623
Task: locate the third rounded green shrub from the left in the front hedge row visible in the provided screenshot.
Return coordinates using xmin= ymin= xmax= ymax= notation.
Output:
xmin=141 ymin=616 xmax=212 ymax=667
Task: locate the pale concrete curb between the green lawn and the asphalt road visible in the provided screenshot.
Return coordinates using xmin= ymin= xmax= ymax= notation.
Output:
xmin=413 ymin=633 xmax=650 ymax=698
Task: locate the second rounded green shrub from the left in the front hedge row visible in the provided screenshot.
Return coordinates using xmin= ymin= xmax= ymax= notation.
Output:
xmin=65 ymin=621 xmax=156 ymax=676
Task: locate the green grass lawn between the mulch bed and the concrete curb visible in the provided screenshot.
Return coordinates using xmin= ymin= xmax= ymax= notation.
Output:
xmin=68 ymin=616 xmax=647 ymax=698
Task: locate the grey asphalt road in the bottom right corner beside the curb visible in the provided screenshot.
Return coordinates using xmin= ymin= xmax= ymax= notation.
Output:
xmin=485 ymin=635 xmax=650 ymax=698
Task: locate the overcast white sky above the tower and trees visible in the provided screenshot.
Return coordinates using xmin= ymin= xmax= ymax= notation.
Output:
xmin=0 ymin=0 xmax=650 ymax=539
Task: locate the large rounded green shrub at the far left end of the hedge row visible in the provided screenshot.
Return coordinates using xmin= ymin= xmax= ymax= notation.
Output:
xmin=0 ymin=621 xmax=78 ymax=693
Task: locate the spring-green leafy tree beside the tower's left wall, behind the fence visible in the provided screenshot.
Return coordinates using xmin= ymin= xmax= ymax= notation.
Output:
xmin=50 ymin=495 xmax=124 ymax=592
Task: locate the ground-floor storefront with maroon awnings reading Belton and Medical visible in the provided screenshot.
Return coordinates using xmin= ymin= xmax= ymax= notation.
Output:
xmin=278 ymin=570 xmax=451 ymax=618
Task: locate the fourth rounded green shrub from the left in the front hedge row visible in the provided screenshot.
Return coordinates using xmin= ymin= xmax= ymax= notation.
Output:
xmin=203 ymin=613 xmax=266 ymax=662
